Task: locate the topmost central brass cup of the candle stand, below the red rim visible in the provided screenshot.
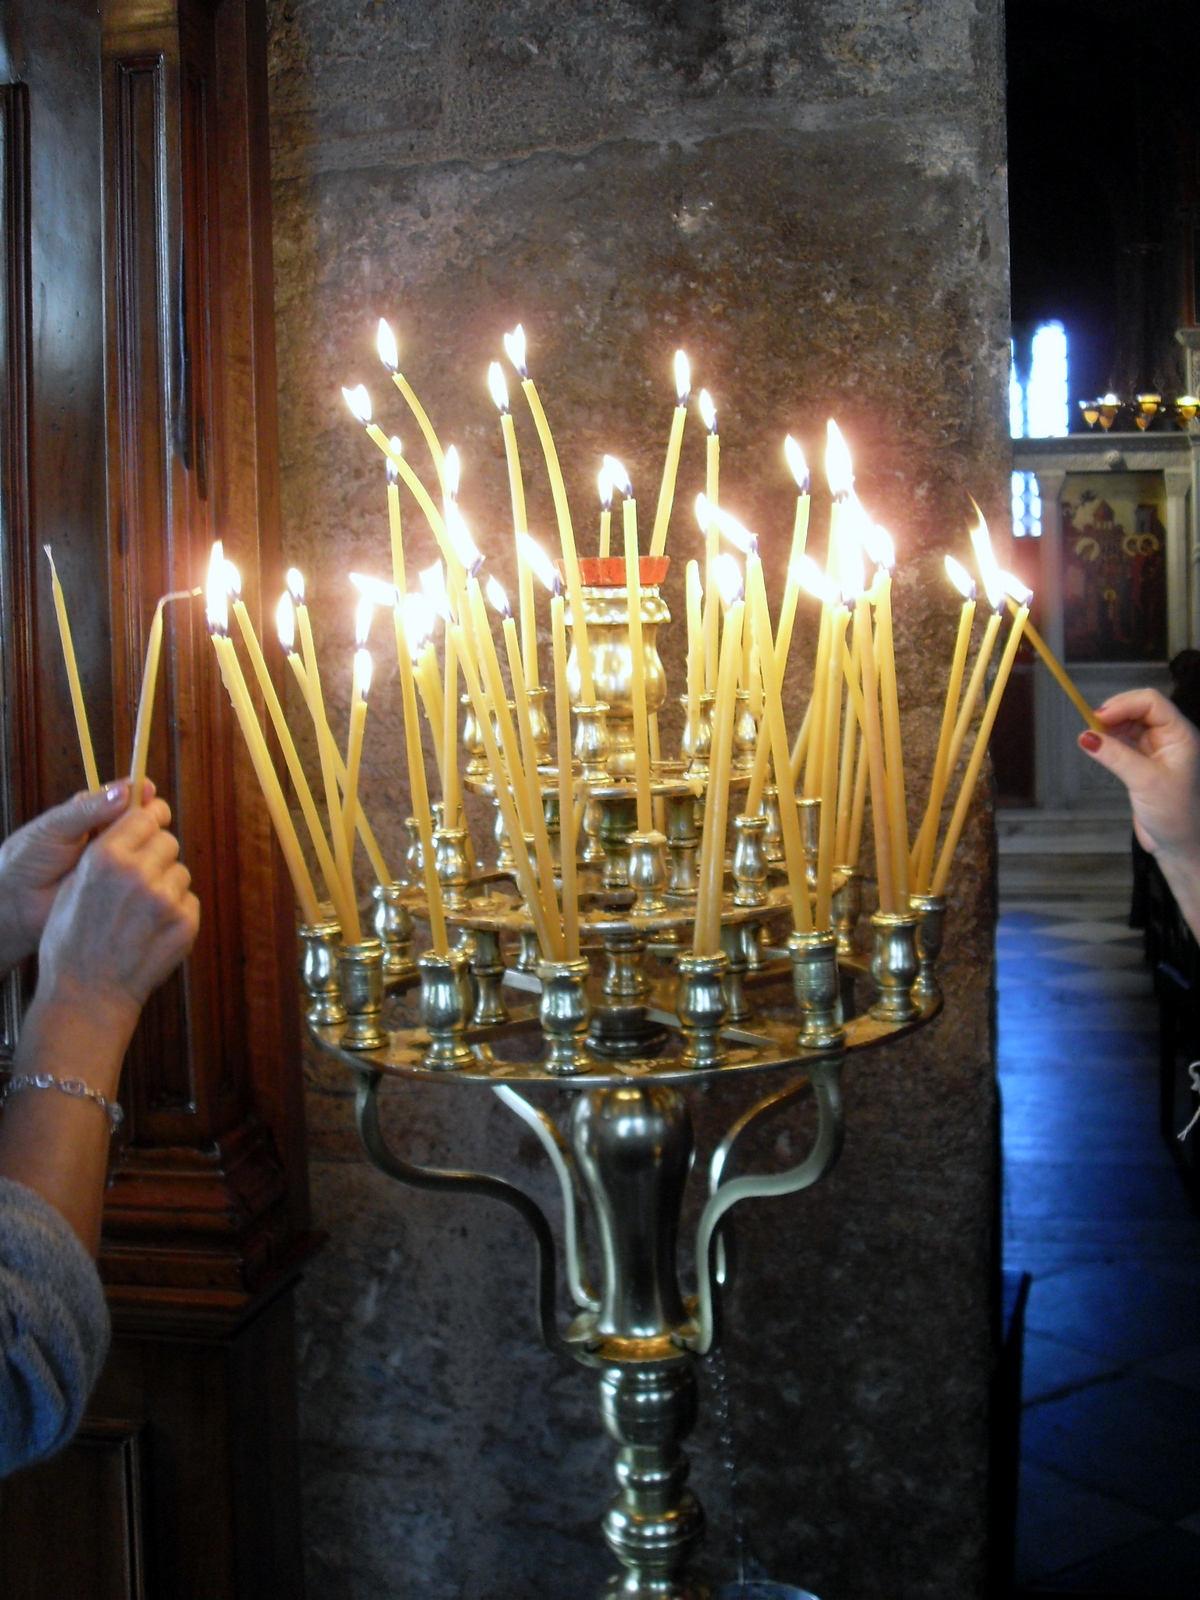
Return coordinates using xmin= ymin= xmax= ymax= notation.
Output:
xmin=566 ymin=586 xmax=670 ymax=778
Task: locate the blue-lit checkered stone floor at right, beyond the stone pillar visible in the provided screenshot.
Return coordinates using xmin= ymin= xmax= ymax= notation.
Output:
xmin=997 ymin=886 xmax=1200 ymax=1600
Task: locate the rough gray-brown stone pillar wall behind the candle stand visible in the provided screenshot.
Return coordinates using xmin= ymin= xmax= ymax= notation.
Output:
xmin=270 ymin=0 xmax=1008 ymax=1600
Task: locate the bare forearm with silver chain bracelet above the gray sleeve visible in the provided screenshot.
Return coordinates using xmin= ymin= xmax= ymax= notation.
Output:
xmin=0 ymin=1000 xmax=131 ymax=1256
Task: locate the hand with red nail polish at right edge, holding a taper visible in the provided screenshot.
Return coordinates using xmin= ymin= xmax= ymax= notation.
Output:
xmin=1078 ymin=690 xmax=1200 ymax=936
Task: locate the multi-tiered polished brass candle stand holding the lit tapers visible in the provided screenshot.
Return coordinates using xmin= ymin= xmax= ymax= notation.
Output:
xmin=302 ymin=569 xmax=944 ymax=1600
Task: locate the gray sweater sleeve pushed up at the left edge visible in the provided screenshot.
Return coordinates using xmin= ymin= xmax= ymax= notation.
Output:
xmin=0 ymin=1178 xmax=109 ymax=1477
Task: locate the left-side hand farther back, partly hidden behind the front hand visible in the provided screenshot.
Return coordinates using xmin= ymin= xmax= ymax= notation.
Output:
xmin=0 ymin=779 xmax=157 ymax=978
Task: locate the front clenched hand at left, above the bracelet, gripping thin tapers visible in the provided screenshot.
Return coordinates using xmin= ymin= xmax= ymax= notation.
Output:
xmin=34 ymin=800 xmax=200 ymax=1053
